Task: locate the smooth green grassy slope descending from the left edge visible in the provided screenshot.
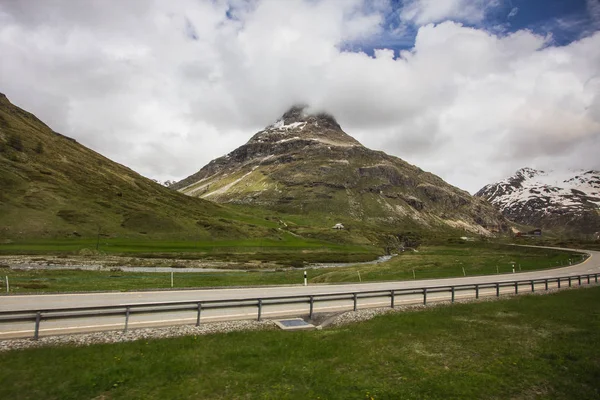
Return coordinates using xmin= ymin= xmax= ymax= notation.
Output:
xmin=0 ymin=94 xmax=269 ymax=240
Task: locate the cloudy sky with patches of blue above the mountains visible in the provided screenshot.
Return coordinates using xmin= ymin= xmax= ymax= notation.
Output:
xmin=0 ymin=0 xmax=600 ymax=192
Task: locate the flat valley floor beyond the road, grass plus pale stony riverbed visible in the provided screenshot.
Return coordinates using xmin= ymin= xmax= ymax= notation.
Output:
xmin=0 ymin=243 xmax=583 ymax=294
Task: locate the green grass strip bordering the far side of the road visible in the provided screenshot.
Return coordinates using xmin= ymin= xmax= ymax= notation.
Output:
xmin=0 ymin=243 xmax=581 ymax=293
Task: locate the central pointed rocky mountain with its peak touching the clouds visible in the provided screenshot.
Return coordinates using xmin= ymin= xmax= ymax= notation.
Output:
xmin=171 ymin=106 xmax=507 ymax=234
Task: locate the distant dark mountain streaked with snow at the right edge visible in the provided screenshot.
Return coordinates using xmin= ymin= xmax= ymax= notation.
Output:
xmin=475 ymin=168 xmax=600 ymax=233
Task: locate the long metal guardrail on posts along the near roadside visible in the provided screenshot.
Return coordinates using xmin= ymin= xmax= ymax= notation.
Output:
xmin=0 ymin=274 xmax=599 ymax=340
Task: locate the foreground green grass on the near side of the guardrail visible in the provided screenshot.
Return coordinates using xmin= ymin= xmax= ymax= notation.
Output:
xmin=0 ymin=287 xmax=600 ymax=399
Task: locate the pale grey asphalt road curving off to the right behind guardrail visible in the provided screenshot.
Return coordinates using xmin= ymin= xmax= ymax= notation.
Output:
xmin=0 ymin=249 xmax=600 ymax=339
